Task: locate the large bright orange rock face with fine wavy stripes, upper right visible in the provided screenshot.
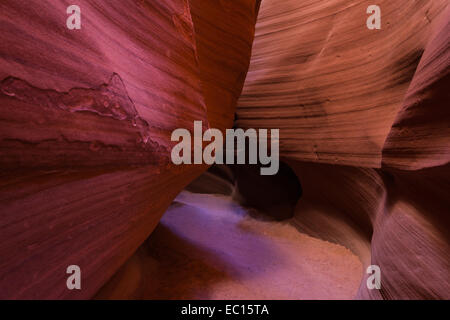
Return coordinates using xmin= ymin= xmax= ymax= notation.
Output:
xmin=236 ymin=0 xmax=447 ymax=167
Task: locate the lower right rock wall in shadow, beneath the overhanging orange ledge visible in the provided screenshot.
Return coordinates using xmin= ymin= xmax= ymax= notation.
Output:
xmin=292 ymin=162 xmax=450 ymax=299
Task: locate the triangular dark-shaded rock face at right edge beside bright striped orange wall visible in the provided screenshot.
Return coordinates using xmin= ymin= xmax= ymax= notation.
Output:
xmin=383 ymin=8 xmax=450 ymax=170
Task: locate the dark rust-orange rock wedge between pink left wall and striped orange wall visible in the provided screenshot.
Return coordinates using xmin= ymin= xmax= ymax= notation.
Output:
xmin=189 ymin=0 xmax=260 ymax=130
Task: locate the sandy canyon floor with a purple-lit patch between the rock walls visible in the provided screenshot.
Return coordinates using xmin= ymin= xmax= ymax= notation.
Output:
xmin=97 ymin=192 xmax=362 ymax=299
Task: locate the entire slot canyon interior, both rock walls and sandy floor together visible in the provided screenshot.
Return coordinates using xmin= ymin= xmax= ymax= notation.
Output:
xmin=0 ymin=0 xmax=450 ymax=299
